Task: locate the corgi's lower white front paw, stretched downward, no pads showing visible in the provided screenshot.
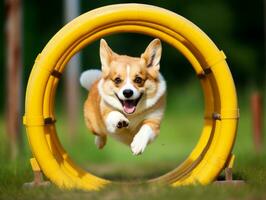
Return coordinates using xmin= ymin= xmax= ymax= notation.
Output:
xmin=130 ymin=124 xmax=156 ymax=155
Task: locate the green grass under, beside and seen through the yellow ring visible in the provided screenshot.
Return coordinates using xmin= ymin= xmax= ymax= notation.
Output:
xmin=0 ymin=83 xmax=266 ymax=200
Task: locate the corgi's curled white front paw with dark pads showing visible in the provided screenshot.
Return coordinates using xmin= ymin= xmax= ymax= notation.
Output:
xmin=105 ymin=111 xmax=129 ymax=133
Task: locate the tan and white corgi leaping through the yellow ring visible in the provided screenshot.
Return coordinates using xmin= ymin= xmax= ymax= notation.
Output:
xmin=80 ymin=39 xmax=166 ymax=155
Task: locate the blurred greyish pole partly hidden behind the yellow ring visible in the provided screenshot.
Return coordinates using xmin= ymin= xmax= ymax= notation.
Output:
xmin=64 ymin=0 xmax=81 ymax=137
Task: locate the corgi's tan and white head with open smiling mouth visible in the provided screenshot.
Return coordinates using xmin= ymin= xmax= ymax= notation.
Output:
xmin=99 ymin=39 xmax=165 ymax=114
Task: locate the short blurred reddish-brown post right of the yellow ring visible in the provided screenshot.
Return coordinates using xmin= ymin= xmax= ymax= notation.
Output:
xmin=251 ymin=92 xmax=263 ymax=152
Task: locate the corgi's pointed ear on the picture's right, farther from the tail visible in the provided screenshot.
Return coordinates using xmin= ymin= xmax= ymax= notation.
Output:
xmin=141 ymin=39 xmax=162 ymax=78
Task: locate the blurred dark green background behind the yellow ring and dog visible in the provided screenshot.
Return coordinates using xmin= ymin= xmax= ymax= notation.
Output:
xmin=0 ymin=0 xmax=266 ymax=198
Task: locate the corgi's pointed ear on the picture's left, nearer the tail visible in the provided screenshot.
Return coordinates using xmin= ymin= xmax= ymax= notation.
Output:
xmin=100 ymin=39 xmax=115 ymax=77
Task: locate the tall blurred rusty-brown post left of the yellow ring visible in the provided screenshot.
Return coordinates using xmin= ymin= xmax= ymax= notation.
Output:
xmin=6 ymin=0 xmax=22 ymax=159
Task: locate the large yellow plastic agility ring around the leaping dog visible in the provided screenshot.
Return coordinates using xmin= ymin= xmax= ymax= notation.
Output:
xmin=24 ymin=4 xmax=238 ymax=190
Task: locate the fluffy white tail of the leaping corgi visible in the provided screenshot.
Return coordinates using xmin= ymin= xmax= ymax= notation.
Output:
xmin=79 ymin=69 xmax=102 ymax=90
